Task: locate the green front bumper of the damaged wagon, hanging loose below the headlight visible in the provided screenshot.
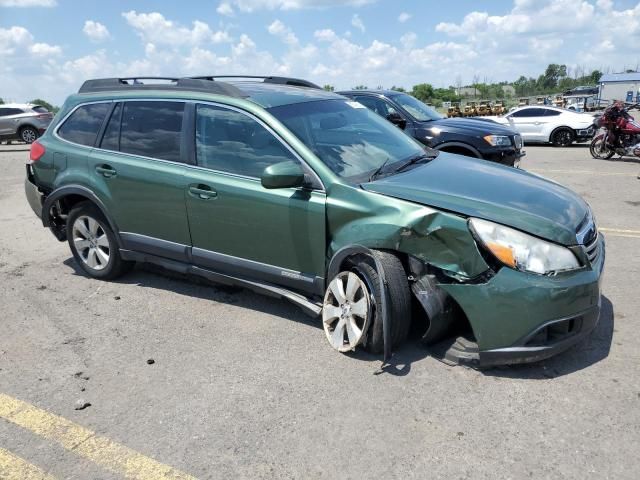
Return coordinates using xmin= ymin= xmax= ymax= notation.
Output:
xmin=440 ymin=235 xmax=605 ymax=367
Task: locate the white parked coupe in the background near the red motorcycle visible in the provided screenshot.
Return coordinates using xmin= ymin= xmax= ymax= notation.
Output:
xmin=485 ymin=105 xmax=596 ymax=147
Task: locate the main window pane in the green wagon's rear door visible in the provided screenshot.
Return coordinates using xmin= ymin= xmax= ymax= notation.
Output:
xmin=120 ymin=101 xmax=184 ymax=162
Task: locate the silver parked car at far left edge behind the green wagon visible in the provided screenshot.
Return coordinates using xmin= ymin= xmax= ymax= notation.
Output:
xmin=0 ymin=103 xmax=53 ymax=143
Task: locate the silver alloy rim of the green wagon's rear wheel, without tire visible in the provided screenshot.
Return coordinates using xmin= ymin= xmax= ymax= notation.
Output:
xmin=72 ymin=215 xmax=111 ymax=270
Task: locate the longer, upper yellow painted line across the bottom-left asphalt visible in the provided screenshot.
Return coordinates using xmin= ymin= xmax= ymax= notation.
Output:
xmin=0 ymin=393 xmax=195 ymax=480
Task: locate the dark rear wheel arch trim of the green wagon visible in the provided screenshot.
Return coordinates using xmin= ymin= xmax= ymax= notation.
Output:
xmin=42 ymin=185 xmax=122 ymax=248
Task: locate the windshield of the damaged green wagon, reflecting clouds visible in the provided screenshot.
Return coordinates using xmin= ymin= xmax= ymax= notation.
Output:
xmin=268 ymin=99 xmax=425 ymax=184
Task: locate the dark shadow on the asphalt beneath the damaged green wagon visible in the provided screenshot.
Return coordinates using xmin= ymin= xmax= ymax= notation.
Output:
xmin=63 ymin=257 xmax=614 ymax=380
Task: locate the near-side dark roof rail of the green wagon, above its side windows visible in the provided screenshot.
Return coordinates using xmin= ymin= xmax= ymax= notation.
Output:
xmin=78 ymin=77 xmax=247 ymax=98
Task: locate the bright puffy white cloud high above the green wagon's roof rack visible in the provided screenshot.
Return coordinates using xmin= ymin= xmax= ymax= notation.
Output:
xmin=122 ymin=10 xmax=231 ymax=45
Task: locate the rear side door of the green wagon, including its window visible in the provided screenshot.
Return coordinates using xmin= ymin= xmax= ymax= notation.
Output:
xmin=88 ymin=100 xmax=191 ymax=261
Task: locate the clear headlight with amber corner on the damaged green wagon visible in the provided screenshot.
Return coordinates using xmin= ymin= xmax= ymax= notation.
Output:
xmin=469 ymin=218 xmax=580 ymax=274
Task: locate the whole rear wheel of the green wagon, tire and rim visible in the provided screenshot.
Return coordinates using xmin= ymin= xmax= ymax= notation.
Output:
xmin=67 ymin=202 xmax=134 ymax=280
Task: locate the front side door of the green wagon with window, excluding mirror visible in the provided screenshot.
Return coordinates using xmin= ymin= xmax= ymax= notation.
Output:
xmin=186 ymin=105 xmax=326 ymax=293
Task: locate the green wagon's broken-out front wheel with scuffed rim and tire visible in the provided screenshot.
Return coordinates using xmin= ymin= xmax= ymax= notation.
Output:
xmin=322 ymin=252 xmax=411 ymax=353
